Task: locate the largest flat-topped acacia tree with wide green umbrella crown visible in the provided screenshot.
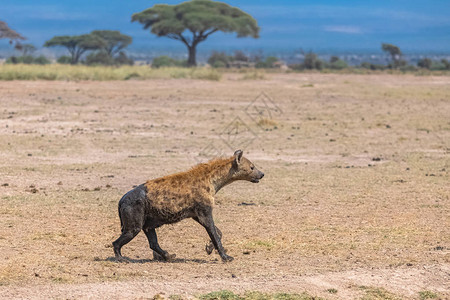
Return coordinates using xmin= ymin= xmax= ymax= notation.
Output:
xmin=131 ymin=0 xmax=259 ymax=66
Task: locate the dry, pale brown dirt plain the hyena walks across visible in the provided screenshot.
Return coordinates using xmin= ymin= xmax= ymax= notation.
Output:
xmin=0 ymin=74 xmax=450 ymax=299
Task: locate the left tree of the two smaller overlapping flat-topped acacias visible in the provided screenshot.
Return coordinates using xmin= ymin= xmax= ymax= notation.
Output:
xmin=44 ymin=34 xmax=105 ymax=64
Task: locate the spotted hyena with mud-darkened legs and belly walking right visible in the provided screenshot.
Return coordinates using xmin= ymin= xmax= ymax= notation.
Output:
xmin=113 ymin=150 xmax=264 ymax=261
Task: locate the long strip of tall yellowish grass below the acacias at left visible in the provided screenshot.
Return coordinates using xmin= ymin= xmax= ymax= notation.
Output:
xmin=0 ymin=64 xmax=221 ymax=81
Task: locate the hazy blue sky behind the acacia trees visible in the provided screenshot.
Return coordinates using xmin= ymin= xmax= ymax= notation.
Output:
xmin=0 ymin=0 xmax=450 ymax=54
